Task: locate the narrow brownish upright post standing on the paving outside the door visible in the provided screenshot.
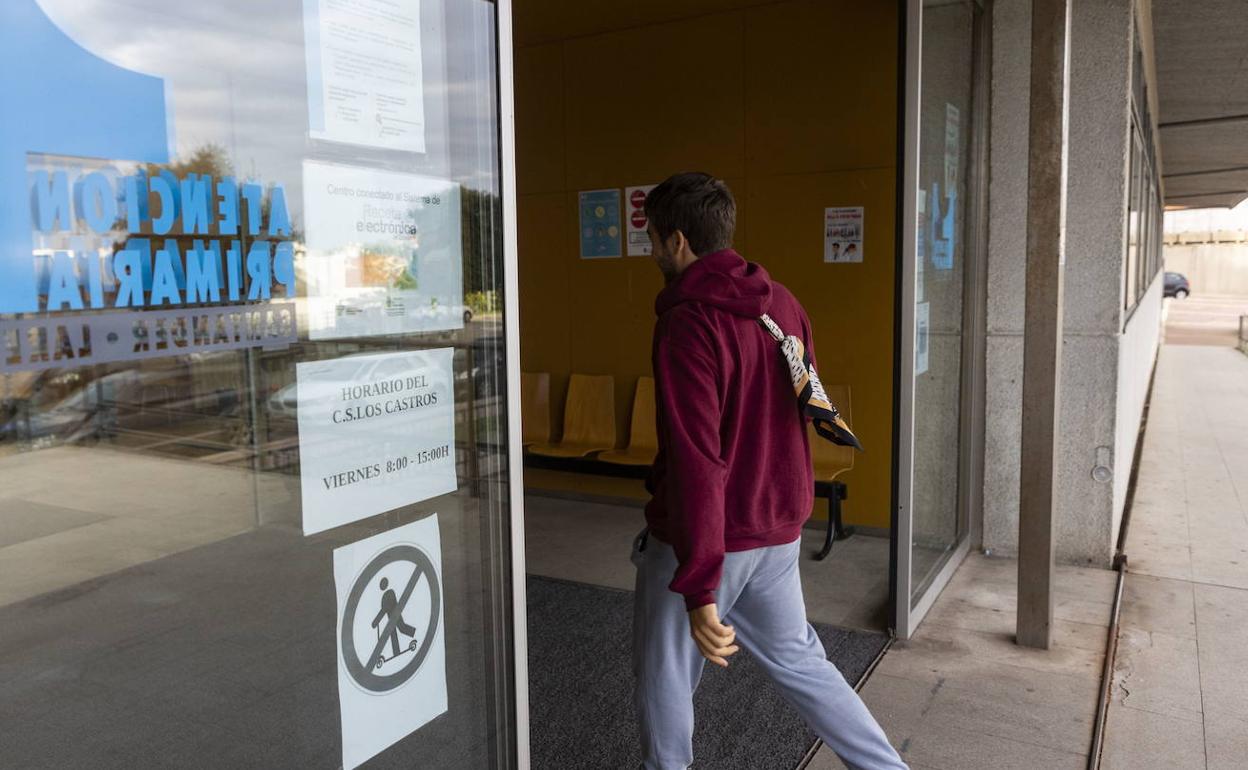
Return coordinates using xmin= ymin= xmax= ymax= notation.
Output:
xmin=1017 ymin=0 xmax=1071 ymax=649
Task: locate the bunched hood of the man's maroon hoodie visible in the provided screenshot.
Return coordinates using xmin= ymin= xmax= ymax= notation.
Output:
xmin=654 ymin=248 xmax=771 ymax=318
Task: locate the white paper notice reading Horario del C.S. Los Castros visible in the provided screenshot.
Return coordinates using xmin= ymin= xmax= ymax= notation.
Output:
xmin=295 ymin=348 xmax=457 ymax=534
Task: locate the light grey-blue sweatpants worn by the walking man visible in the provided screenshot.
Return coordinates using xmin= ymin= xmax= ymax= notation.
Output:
xmin=633 ymin=537 xmax=906 ymax=770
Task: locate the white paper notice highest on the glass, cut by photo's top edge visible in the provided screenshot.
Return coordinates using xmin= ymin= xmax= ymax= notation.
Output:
xmin=303 ymin=0 xmax=424 ymax=152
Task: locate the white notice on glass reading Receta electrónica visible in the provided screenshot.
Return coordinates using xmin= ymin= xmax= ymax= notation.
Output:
xmin=303 ymin=161 xmax=464 ymax=339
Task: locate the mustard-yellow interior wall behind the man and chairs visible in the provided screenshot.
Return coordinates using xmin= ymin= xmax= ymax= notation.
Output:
xmin=515 ymin=0 xmax=897 ymax=528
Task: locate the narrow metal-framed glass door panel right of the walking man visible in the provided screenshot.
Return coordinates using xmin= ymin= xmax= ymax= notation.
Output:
xmin=895 ymin=0 xmax=987 ymax=638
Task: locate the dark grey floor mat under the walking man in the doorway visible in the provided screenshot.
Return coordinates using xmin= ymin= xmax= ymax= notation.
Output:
xmin=528 ymin=575 xmax=887 ymax=770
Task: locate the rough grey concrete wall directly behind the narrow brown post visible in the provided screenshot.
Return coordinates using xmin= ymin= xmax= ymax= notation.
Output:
xmin=982 ymin=0 xmax=1156 ymax=565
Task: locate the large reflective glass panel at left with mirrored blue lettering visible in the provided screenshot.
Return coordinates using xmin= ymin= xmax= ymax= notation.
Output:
xmin=0 ymin=0 xmax=517 ymax=769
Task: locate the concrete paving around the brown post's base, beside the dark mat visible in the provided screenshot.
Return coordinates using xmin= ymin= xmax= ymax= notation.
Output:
xmin=807 ymin=553 xmax=1117 ymax=770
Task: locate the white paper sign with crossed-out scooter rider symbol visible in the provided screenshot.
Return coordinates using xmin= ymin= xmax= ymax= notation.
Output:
xmin=333 ymin=514 xmax=447 ymax=770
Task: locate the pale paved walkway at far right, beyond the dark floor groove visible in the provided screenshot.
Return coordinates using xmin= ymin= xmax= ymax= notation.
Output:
xmin=1102 ymin=346 xmax=1248 ymax=769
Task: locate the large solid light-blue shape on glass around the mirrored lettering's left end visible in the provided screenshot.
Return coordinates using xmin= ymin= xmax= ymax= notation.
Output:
xmin=0 ymin=0 xmax=168 ymax=313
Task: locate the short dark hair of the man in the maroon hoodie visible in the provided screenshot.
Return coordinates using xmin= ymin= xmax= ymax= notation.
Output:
xmin=645 ymin=172 xmax=736 ymax=257
